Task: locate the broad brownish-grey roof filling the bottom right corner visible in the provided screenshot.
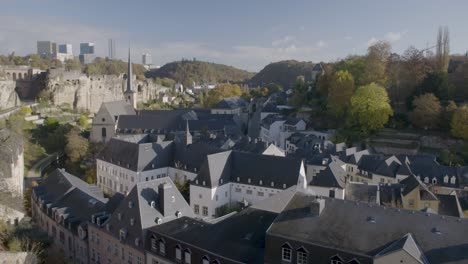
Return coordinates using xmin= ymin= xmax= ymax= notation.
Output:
xmin=268 ymin=193 xmax=468 ymax=263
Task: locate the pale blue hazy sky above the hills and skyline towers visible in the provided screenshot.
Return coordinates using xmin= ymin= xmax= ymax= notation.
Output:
xmin=0 ymin=0 xmax=468 ymax=72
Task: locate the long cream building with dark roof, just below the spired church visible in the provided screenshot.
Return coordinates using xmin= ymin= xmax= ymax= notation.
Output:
xmin=96 ymin=134 xmax=221 ymax=194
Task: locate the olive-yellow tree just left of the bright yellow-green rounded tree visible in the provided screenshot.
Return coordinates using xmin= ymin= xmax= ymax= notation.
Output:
xmin=327 ymin=71 xmax=354 ymax=117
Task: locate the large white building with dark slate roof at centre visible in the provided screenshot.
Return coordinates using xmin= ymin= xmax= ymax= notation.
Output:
xmin=190 ymin=151 xmax=307 ymax=219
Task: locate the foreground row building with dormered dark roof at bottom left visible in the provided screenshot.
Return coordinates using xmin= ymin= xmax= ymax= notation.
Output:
xmin=31 ymin=169 xmax=111 ymax=264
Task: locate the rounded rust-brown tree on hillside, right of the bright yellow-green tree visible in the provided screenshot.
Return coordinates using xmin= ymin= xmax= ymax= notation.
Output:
xmin=409 ymin=93 xmax=442 ymax=129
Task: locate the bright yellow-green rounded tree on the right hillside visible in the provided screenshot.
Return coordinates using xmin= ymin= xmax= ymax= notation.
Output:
xmin=351 ymin=83 xmax=393 ymax=133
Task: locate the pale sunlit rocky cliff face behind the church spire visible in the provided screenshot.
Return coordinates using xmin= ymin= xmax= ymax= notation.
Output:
xmin=45 ymin=70 xmax=168 ymax=112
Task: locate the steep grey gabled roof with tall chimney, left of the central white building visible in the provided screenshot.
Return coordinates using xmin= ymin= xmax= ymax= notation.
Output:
xmin=97 ymin=177 xmax=194 ymax=249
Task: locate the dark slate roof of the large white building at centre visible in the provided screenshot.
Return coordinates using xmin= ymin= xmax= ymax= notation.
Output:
xmin=191 ymin=151 xmax=301 ymax=189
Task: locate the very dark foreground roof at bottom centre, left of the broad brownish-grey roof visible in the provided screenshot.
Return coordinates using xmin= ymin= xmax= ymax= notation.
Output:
xmin=150 ymin=208 xmax=278 ymax=263
